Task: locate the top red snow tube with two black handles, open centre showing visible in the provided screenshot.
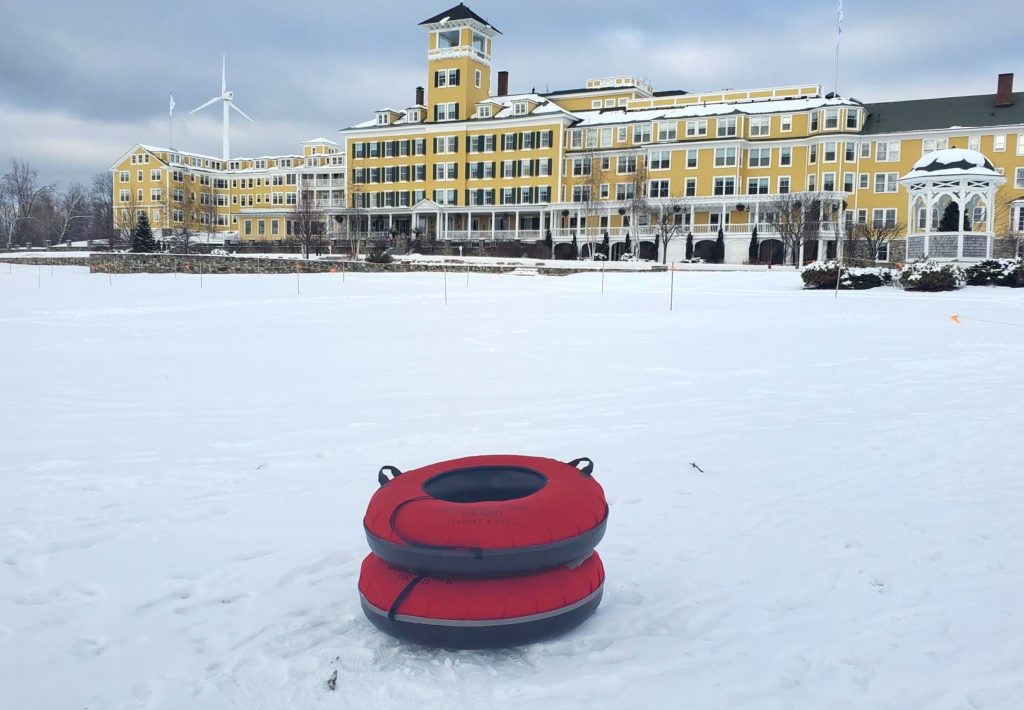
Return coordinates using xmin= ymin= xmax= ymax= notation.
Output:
xmin=362 ymin=456 xmax=608 ymax=577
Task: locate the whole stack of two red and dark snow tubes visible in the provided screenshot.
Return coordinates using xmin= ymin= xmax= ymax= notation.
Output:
xmin=359 ymin=456 xmax=608 ymax=649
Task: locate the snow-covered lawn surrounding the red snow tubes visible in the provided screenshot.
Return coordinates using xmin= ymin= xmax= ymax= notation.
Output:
xmin=0 ymin=265 xmax=1024 ymax=710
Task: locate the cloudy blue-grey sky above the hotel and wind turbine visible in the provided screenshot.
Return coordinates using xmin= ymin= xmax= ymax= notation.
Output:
xmin=0 ymin=0 xmax=1024 ymax=182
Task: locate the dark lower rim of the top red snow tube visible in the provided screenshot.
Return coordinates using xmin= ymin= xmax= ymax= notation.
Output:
xmin=364 ymin=506 xmax=608 ymax=578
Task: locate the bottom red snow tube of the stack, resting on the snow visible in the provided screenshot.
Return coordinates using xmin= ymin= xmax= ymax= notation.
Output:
xmin=359 ymin=552 xmax=604 ymax=649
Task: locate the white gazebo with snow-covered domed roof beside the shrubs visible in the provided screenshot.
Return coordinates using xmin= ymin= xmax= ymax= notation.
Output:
xmin=900 ymin=148 xmax=1007 ymax=261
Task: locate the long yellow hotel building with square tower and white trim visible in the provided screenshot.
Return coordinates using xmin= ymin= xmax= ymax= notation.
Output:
xmin=112 ymin=4 xmax=1024 ymax=263
